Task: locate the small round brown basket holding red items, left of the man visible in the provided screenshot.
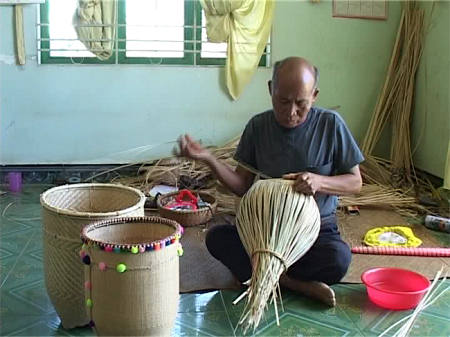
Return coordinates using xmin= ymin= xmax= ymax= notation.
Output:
xmin=157 ymin=191 xmax=217 ymax=227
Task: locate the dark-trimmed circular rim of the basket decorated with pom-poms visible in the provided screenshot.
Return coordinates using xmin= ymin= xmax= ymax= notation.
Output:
xmin=81 ymin=216 xmax=183 ymax=248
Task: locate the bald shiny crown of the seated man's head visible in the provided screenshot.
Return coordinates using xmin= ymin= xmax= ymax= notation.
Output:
xmin=272 ymin=57 xmax=319 ymax=90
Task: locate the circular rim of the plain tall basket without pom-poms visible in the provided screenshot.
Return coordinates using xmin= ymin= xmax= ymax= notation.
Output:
xmin=40 ymin=183 xmax=146 ymax=218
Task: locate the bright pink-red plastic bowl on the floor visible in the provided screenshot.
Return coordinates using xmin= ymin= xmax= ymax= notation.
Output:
xmin=361 ymin=268 xmax=431 ymax=310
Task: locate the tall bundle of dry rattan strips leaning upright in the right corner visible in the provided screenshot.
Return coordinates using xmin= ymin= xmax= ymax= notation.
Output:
xmin=361 ymin=1 xmax=426 ymax=186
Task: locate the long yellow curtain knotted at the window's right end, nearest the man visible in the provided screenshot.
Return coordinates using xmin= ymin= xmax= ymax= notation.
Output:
xmin=200 ymin=0 xmax=275 ymax=99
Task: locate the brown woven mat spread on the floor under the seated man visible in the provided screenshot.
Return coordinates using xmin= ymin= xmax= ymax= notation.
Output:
xmin=180 ymin=209 xmax=450 ymax=293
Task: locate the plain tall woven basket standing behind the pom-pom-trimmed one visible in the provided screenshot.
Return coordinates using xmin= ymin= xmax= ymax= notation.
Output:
xmin=41 ymin=184 xmax=145 ymax=329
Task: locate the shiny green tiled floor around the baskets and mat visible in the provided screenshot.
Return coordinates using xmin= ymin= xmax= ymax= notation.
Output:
xmin=0 ymin=185 xmax=450 ymax=336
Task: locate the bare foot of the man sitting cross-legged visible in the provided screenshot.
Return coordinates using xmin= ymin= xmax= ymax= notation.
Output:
xmin=280 ymin=275 xmax=336 ymax=307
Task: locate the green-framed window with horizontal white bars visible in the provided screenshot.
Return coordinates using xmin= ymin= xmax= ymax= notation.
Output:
xmin=38 ymin=0 xmax=269 ymax=66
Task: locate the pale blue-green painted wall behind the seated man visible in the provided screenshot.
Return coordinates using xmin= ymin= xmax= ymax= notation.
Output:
xmin=0 ymin=0 xmax=400 ymax=164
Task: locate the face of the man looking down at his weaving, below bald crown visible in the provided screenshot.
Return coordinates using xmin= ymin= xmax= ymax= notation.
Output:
xmin=270 ymin=78 xmax=319 ymax=129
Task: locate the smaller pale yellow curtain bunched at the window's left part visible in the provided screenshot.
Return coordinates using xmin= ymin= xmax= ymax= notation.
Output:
xmin=72 ymin=0 xmax=117 ymax=61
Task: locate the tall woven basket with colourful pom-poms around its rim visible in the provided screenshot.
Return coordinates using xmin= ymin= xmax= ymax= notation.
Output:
xmin=80 ymin=217 xmax=182 ymax=336
